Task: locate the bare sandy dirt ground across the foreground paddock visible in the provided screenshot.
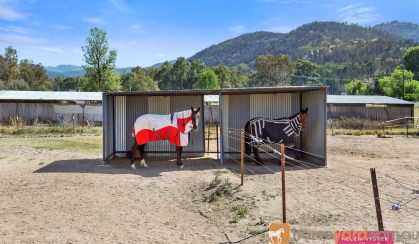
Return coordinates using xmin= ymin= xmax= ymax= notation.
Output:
xmin=0 ymin=136 xmax=419 ymax=243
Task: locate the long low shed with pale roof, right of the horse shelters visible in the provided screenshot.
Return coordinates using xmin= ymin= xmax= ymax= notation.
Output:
xmin=327 ymin=95 xmax=414 ymax=121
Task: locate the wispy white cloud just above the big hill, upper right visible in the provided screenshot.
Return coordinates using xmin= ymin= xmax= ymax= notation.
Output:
xmin=337 ymin=4 xmax=378 ymax=24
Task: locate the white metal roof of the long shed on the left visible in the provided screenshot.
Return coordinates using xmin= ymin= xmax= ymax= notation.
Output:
xmin=0 ymin=90 xmax=102 ymax=101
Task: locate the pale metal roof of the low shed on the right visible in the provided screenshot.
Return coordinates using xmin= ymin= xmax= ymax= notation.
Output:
xmin=327 ymin=95 xmax=414 ymax=105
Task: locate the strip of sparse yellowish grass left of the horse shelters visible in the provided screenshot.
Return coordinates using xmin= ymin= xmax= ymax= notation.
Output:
xmin=0 ymin=135 xmax=102 ymax=155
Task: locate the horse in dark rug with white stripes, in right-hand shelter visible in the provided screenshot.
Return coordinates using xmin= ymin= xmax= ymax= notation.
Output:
xmin=244 ymin=108 xmax=308 ymax=164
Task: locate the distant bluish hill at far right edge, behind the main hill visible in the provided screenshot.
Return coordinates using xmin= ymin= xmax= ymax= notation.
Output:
xmin=374 ymin=21 xmax=419 ymax=43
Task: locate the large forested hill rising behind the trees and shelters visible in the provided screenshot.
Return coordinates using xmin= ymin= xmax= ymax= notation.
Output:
xmin=191 ymin=22 xmax=414 ymax=69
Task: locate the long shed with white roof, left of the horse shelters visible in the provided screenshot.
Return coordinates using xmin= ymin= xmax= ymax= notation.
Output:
xmin=0 ymin=91 xmax=102 ymax=122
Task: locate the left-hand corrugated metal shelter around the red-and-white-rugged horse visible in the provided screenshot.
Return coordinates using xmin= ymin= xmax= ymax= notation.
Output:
xmin=102 ymin=90 xmax=209 ymax=161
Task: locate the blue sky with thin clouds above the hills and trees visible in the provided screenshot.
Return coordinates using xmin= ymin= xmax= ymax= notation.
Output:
xmin=0 ymin=0 xmax=419 ymax=67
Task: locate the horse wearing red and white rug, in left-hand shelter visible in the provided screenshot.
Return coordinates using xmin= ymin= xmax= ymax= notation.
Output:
xmin=130 ymin=107 xmax=200 ymax=169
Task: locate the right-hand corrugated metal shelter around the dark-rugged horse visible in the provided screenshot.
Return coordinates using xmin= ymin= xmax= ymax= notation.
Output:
xmin=220 ymin=86 xmax=327 ymax=165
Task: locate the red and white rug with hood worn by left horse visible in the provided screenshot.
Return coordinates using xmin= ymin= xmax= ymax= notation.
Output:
xmin=132 ymin=110 xmax=193 ymax=147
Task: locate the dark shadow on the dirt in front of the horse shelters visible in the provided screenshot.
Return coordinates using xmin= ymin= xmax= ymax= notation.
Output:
xmin=34 ymin=157 xmax=324 ymax=177
